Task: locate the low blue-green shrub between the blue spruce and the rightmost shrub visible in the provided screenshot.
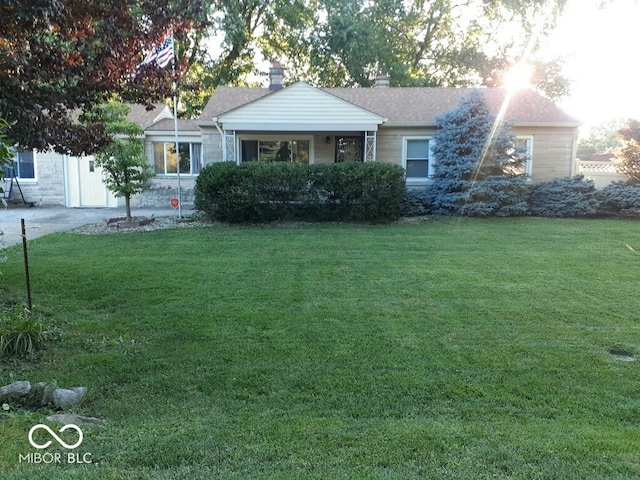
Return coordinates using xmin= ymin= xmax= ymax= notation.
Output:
xmin=528 ymin=175 xmax=600 ymax=217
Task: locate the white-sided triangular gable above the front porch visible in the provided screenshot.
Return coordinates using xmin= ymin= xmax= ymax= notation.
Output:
xmin=217 ymin=82 xmax=386 ymax=132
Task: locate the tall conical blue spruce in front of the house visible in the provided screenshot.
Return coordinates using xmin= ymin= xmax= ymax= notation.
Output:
xmin=428 ymin=90 xmax=527 ymax=216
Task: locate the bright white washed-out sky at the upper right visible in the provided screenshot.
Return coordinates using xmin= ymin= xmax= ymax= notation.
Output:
xmin=547 ymin=0 xmax=640 ymax=132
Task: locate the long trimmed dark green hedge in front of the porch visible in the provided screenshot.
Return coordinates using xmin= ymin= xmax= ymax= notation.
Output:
xmin=195 ymin=162 xmax=405 ymax=223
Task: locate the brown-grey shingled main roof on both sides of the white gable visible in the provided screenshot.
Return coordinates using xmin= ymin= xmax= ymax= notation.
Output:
xmin=200 ymin=87 xmax=580 ymax=126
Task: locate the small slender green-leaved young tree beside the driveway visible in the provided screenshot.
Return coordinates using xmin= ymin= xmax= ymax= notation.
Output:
xmin=89 ymin=101 xmax=154 ymax=222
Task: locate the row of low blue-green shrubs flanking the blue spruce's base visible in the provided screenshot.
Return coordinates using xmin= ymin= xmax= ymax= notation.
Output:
xmin=401 ymin=175 xmax=640 ymax=217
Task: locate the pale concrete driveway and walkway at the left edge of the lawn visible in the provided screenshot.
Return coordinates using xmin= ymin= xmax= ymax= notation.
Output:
xmin=0 ymin=204 xmax=181 ymax=248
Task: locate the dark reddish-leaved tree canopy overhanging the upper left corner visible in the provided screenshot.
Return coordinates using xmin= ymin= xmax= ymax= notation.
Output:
xmin=0 ymin=0 xmax=204 ymax=154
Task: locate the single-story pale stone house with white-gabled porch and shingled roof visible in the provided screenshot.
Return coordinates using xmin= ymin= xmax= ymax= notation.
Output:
xmin=5 ymin=64 xmax=580 ymax=208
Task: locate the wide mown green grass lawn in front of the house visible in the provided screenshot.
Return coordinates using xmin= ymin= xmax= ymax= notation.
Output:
xmin=0 ymin=218 xmax=640 ymax=479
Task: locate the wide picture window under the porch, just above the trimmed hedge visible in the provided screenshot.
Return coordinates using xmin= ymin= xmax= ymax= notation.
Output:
xmin=240 ymin=139 xmax=310 ymax=165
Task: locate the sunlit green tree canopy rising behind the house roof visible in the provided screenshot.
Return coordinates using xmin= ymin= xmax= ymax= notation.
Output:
xmin=195 ymin=0 xmax=568 ymax=104
